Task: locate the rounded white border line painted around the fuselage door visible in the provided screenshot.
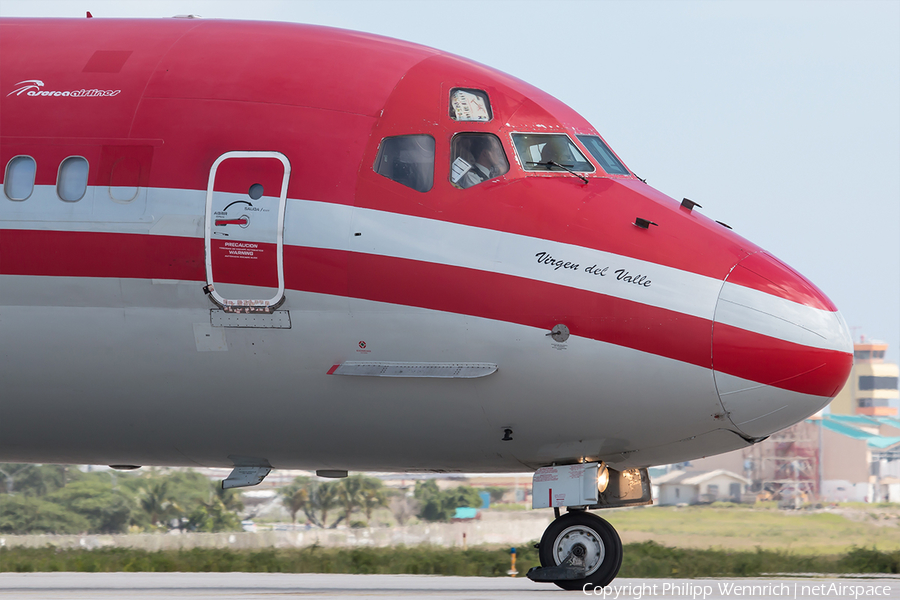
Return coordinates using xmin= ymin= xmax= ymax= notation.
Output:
xmin=203 ymin=150 xmax=291 ymax=312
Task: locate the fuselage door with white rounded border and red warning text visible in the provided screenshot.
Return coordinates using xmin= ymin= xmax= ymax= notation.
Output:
xmin=204 ymin=152 xmax=291 ymax=312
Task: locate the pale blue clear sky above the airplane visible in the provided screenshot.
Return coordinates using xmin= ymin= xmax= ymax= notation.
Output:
xmin=0 ymin=0 xmax=900 ymax=362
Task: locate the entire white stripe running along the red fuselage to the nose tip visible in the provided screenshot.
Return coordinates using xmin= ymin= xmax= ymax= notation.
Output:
xmin=0 ymin=186 xmax=835 ymax=348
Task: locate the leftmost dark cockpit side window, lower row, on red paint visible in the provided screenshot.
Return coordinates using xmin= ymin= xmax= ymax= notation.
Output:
xmin=373 ymin=135 xmax=434 ymax=192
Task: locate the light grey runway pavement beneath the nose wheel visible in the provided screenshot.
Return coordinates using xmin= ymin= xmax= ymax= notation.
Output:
xmin=0 ymin=573 xmax=900 ymax=600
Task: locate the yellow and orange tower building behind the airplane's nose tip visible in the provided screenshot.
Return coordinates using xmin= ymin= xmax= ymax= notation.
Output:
xmin=829 ymin=341 xmax=900 ymax=417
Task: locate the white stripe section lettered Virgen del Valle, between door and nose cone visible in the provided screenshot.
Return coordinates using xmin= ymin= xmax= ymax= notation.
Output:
xmin=298 ymin=201 xmax=722 ymax=319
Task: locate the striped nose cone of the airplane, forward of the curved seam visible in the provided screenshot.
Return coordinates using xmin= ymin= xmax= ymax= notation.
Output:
xmin=712 ymin=252 xmax=853 ymax=438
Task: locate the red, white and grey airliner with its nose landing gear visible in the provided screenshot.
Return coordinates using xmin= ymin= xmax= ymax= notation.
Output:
xmin=0 ymin=18 xmax=852 ymax=588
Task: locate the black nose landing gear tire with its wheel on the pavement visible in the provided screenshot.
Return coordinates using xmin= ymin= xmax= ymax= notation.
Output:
xmin=538 ymin=511 xmax=622 ymax=590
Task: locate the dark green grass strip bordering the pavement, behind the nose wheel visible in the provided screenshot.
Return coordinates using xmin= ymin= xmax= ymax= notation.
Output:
xmin=0 ymin=542 xmax=900 ymax=578
